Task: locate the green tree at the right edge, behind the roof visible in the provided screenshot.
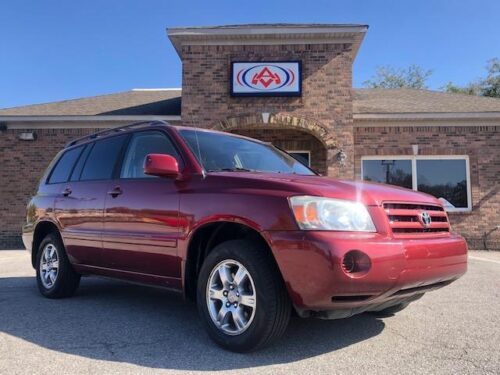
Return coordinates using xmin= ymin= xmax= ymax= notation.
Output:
xmin=443 ymin=58 xmax=500 ymax=98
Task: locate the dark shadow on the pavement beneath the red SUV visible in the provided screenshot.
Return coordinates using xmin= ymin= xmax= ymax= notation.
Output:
xmin=0 ymin=277 xmax=384 ymax=371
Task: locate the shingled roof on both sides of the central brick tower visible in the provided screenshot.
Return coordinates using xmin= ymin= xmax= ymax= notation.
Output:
xmin=0 ymin=89 xmax=500 ymax=116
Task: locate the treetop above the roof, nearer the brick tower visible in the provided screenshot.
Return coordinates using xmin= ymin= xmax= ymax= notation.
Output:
xmin=363 ymin=65 xmax=432 ymax=89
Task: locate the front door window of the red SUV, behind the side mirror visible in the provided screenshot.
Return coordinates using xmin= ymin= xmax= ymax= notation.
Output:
xmin=120 ymin=131 xmax=180 ymax=178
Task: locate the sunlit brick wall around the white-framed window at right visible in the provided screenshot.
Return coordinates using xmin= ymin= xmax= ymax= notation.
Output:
xmin=354 ymin=126 xmax=500 ymax=249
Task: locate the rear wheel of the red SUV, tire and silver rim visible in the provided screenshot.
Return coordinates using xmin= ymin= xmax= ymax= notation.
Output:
xmin=35 ymin=233 xmax=80 ymax=298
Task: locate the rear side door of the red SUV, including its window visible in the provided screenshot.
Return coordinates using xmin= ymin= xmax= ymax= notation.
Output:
xmin=55 ymin=135 xmax=126 ymax=267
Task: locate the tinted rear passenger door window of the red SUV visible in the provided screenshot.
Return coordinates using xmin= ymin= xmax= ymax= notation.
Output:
xmin=80 ymin=134 xmax=127 ymax=181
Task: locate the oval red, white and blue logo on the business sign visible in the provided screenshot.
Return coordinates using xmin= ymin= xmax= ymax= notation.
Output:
xmin=236 ymin=65 xmax=296 ymax=91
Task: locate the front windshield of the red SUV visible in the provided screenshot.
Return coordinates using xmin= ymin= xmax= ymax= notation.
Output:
xmin=179 ymin=129 xmax=315 ymax=175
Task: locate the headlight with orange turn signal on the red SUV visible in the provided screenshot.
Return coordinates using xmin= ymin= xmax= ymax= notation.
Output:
xmin=289 ymin=196 xmax=376 ymax=232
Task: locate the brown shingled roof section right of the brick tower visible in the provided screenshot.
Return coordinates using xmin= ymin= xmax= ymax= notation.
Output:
xmin=353 ymin=88 xmax=500 ymax=114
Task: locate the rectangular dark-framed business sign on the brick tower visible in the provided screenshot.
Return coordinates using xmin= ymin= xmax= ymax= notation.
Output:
xmin=231 ymin=61 xmax=302 ymax=96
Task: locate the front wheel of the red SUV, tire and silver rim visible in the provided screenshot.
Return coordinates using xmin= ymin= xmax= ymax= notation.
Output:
xmin=197 ymin=240 xmax=291 ymax=352
